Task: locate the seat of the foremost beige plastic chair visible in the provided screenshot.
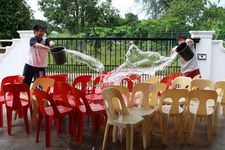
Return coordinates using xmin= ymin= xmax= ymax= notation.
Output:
xmin=108 ymin=114 xmax=144 ymax=125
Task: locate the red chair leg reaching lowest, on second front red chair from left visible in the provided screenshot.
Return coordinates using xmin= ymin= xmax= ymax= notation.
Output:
xmin=45 ymin=116 xmax=52 ymax=147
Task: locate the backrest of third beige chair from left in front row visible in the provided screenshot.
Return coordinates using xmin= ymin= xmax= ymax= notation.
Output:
xmin=158 ymin=89 xmax=188 ymax=115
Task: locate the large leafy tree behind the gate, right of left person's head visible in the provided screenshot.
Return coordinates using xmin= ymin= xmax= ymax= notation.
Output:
xmin=39 ymin=0 xmax=120 ymax=33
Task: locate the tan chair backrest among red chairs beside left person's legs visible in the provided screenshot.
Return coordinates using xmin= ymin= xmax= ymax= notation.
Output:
xmin=31 ymin=77 xmax=55 ymax=95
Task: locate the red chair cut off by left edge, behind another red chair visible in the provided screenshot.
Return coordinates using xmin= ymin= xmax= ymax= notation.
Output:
xmin=0 ymin=75 xmax=24 ymax=128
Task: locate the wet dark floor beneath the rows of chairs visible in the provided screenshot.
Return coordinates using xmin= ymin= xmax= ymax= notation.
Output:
xmin=0 ymin=108 xmax=225 ymax=150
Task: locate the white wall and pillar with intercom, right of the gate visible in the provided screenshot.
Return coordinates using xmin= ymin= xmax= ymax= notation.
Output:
xmin=190 ymin=31 xmax=225 ymax=82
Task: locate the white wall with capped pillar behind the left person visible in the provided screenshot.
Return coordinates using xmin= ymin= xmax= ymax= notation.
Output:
xmin=0 ymin=30 xmax=33 ymax=82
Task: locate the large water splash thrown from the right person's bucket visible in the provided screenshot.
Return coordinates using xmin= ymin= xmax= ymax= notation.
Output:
xmin=103 ymin=42 xmax=177 ymax=84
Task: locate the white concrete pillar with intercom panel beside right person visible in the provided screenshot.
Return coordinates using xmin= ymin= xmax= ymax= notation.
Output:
xmin=189 ymin=31 xmax=215 ymax=79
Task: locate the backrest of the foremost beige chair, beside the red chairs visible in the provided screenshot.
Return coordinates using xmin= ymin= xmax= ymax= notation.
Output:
xmin=102 ymin=87 xmax=129 ymax=120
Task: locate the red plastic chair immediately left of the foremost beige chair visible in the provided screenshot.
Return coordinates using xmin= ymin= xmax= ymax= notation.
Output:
xmin=60 ymin=83 xmax=106 ymax=143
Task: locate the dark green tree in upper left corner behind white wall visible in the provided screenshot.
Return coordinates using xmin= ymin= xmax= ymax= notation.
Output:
xmin=0 ymin=0 xmax=32 ymax=39
